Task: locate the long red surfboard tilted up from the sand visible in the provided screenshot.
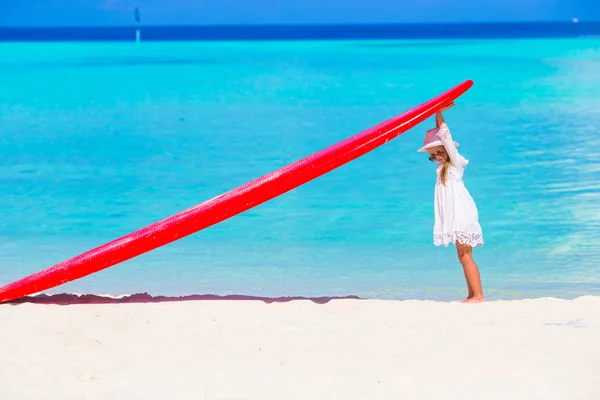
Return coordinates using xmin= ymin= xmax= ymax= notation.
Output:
xmin=0 ymin=80 xmax=473 ymax=302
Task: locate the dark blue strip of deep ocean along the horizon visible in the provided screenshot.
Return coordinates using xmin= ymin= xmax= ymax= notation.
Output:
xmin=0 ymin=21 xmax=600 ymax=41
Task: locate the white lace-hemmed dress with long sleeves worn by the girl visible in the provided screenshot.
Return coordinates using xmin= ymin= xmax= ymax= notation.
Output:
xmin=433 ymin=122 xmax=483 ymax=247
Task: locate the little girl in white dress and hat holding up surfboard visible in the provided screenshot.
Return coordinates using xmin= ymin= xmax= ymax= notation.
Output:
xmin=417 ymin=103 xmax=485 ymax=303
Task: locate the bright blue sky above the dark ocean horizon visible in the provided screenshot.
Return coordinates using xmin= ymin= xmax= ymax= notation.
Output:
xmin=0 ymin=0 xmax=600 ymax=26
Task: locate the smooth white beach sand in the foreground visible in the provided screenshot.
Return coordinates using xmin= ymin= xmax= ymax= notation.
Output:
xmin=0 ymin=297 xmax=600 ymax=400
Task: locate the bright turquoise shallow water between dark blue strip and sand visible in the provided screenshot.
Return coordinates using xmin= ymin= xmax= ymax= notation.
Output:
xmin=0 ymin=30 xmax=600 ymax=300
